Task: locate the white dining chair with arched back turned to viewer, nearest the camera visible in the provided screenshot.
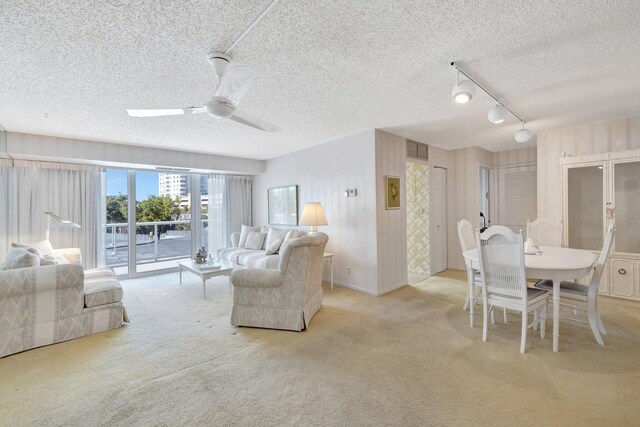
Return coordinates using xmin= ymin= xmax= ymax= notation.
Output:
xmin=476 ymin=225 xmax=549 ymax=353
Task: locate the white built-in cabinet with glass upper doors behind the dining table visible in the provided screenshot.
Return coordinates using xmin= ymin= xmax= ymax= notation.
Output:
xmin=560 ymin=150 xmax=640 ymax=300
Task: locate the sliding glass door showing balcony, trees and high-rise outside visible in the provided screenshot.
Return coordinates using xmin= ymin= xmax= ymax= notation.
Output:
xmin=106 ymin=169 xmax=207 ymax=276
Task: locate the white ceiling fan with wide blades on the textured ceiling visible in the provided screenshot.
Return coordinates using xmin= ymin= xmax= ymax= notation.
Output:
xmin=127 ymin=52 xmax=282 ymax=132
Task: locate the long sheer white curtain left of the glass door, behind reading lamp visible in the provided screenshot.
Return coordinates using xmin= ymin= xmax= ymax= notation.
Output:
xmin=0 ymin=160 xmax=105 ymax=268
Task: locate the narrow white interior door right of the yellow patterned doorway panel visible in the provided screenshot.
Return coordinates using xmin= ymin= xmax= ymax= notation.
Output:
xmin=429 ymin=168 xmax=447 ymax=274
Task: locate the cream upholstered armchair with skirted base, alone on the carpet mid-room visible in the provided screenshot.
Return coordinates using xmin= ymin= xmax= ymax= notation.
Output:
xmin=231 ymin=233 xmax=329 ymax=331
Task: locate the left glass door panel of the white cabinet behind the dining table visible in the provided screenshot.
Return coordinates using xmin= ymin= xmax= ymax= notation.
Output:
xmin=566 ymin=165 xmax=605 ymax=251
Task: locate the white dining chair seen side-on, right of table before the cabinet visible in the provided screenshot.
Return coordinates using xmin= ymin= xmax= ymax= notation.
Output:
xmin=533 ymin=222 xmax=616 ymax=345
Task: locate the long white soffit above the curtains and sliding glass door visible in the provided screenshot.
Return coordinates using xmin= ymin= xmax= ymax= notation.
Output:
xmin=0 ymin=132 xmax=265 ymax=175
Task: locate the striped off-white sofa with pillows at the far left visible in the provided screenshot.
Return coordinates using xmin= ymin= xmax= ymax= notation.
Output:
xmin=0 ymin=244 xmax=128 ymax=357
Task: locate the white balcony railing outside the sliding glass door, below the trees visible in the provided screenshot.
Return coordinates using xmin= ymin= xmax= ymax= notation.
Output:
xmin=105 ymin=219 xmax=208 ymax=267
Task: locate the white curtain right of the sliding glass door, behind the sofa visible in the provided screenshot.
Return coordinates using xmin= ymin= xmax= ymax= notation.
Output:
xmin=207 ymin=174 xmax=253 ymax=254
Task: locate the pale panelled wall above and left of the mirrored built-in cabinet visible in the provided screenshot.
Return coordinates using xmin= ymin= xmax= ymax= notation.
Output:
xmin=537 ymin=116 xmax=640 ymax=221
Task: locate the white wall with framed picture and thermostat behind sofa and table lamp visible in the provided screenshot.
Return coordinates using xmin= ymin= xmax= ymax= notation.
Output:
xmin=253 ymin=130 xmax=380 ymax=295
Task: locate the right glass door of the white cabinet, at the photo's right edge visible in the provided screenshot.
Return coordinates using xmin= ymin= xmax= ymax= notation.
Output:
xmin=613 ymin=162 xmax=640 ymax=253
